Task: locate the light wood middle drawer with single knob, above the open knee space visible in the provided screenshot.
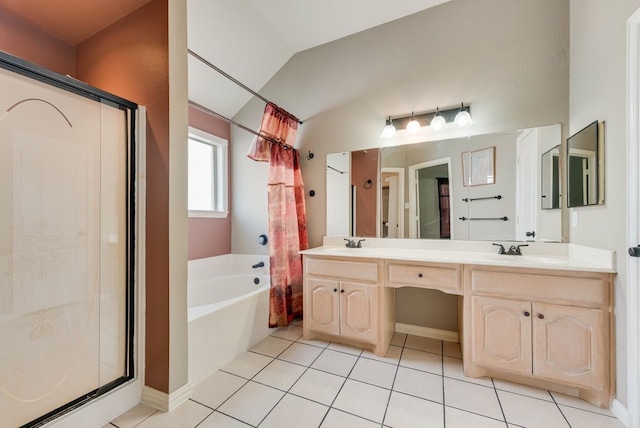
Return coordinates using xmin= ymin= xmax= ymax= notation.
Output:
xmin=387 ymin=263 xmax=462 ymax=294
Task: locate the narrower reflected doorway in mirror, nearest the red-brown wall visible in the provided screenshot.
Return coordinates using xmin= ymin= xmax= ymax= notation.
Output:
xmin=380 ymin=168 xmax=405 ymax=238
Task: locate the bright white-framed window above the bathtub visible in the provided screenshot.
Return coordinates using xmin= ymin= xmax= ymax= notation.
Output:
xmin=188 ymin=127 xmax=229 ymax=218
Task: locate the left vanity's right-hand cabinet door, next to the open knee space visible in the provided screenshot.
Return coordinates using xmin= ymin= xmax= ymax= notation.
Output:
xmin=340 ymin=282 xmax=378 ymax=343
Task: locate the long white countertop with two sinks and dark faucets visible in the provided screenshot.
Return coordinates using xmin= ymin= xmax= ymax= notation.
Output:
xmin=300 ymin=237 xmax=615 ymax=273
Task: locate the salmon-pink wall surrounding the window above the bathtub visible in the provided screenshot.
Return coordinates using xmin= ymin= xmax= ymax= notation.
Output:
xmin=189 ymin=107 xmax=233 ymax=260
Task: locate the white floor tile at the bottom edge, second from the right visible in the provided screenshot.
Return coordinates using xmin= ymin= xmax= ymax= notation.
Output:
xmin=498 ymin=391 xmax=569 ymax=428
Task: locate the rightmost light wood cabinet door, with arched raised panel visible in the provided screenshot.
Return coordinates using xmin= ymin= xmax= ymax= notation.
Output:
xmin=532 ymin=303 xmax=608 ymax=388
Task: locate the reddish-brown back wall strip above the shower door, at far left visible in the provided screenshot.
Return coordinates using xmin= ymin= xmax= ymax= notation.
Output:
xmin=0 ymin=12 xmax=76 ymax=76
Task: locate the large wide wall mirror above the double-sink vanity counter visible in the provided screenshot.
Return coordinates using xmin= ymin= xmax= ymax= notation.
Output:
xmin=326 ymin=125 xmax=562 ymax=242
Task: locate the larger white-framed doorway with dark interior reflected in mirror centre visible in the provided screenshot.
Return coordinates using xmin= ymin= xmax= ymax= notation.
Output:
xmin=409 ymin=158 xmax=453 ymax=239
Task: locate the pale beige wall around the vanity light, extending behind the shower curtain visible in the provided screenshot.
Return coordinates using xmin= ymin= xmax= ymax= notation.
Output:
xmin=232 ymin=0 xmax=569 ymax=253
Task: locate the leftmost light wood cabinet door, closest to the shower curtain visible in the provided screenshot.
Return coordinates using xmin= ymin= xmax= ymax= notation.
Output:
xmin=304 ymin=278 xmax=340 ymax=334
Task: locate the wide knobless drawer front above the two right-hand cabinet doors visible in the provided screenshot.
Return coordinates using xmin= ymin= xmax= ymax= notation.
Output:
xmin=471 ymin=269 xmax=608 ymax=307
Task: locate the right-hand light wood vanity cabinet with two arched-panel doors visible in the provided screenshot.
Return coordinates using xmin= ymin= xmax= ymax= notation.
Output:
xmin=464 ymin=266 xmax=614 ymax=407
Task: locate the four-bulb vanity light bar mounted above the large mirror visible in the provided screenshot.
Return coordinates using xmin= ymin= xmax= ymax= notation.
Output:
xmin=380 ymin=103 xmax=473 ymax=138
